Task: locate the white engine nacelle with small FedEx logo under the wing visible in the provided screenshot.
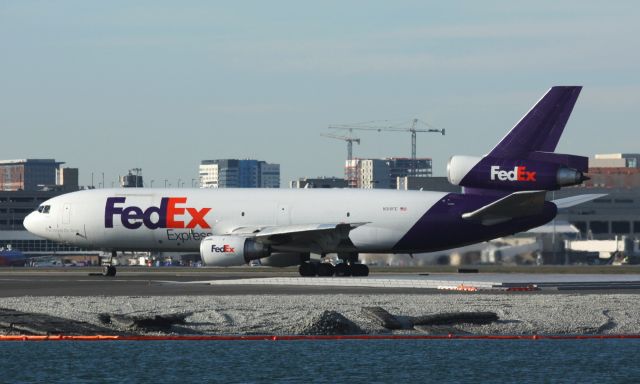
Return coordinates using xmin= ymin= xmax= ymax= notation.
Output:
xmin=200 ymin=236 xmax=271 ymax=267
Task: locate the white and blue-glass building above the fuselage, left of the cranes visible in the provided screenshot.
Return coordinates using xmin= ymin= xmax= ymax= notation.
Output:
xmin=199 ymin=159 xmax=280 ymax=188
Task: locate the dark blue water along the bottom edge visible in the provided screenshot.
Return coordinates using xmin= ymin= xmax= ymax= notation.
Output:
xmin=0 ymin=340 xmax=640 ymax=384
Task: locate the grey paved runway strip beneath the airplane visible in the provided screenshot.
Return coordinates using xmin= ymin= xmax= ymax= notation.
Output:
xmin=0 ymin=268 xmax=640 ymax=297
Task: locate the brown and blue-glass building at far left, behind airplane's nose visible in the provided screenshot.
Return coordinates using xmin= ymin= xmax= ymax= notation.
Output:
xmin=0 ymin=159 xmax=64 ymax=191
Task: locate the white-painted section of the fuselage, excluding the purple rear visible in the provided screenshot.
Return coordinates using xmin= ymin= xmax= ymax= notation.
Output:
xmin=25 ymin=188 xmax=446 ymax=252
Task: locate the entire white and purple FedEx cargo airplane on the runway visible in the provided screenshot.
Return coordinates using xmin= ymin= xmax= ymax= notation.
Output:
xmin=24 ymin=87 xmax=597 ymax=276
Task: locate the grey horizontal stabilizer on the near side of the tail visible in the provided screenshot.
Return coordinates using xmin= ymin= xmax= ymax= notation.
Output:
xmin=462 ymin=191 xmax=547 ymax=225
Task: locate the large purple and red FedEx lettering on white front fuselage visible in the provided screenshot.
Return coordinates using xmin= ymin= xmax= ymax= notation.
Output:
xmin=104 ymin=197 xmax=211 ymax=229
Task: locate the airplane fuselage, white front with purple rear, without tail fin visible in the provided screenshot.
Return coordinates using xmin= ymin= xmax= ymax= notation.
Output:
xmin=25 ymin=188 xmax=556 ymax=253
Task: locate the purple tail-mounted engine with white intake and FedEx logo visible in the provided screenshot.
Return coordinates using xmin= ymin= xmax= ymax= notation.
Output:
xmin=447 ymin=152 xmax=589 ymax=191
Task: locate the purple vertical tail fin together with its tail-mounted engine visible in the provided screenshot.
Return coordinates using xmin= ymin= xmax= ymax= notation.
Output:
xmin=447 ymin=86 xmax=588 ymax=196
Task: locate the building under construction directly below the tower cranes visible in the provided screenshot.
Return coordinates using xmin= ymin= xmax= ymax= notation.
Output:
xmin=345 ymin=157 xmax=432 ymax=189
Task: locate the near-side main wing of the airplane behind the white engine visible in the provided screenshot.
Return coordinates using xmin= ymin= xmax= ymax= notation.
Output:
xmin=229 ymin=223 xmax=367 ymax=253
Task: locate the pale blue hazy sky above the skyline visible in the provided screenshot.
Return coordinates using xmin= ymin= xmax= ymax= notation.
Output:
xmin=0 ymin=1 xmax=640 ymax=186
